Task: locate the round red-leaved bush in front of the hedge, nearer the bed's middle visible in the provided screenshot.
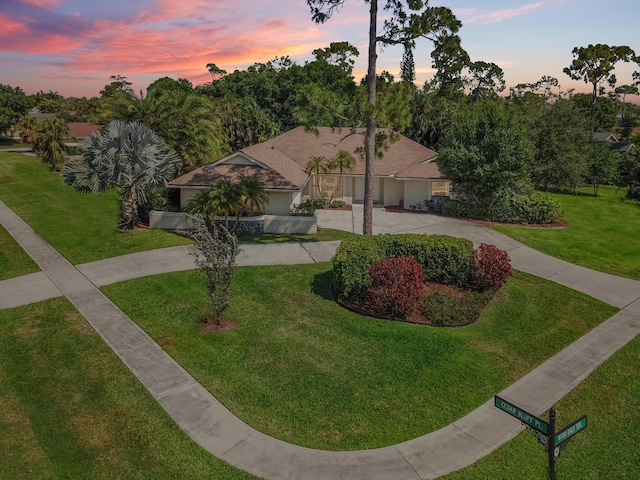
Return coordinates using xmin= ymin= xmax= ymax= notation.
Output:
xmin=365 ymin=257 xmax=426 ymax=320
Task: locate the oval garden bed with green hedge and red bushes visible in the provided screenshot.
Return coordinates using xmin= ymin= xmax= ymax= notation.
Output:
xmin=333 ymin=234 xmax=511 ymax=326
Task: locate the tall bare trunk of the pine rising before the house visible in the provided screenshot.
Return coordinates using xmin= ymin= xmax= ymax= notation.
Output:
xmin=362 ymin=0 xmax=378 ymax=235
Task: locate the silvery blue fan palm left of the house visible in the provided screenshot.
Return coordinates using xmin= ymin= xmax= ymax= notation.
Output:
xmin=62 ymin=120 xmax=180 ymax=230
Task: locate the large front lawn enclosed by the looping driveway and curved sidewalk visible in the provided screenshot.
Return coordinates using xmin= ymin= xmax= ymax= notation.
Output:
xmin=103 ymin=263 xmax=616 ymax=450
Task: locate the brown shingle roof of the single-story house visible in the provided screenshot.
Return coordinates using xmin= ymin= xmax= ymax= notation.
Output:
xmin=169 ymin=127 xmax=444 ymax=190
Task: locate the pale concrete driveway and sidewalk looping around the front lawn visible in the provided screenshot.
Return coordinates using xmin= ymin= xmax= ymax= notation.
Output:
xmin=0 ymin=202 xmax=640 ymax=480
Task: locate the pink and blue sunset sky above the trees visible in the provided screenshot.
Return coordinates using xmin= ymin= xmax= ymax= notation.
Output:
xmin=0 ymin=0 xmax=640 ymax=100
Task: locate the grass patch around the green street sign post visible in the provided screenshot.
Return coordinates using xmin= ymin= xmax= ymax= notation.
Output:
xmin=442 ymin=337 xmax=640 ymax=480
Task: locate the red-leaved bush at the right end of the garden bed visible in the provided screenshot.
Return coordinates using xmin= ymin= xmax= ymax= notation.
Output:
xmin=469 ymin=243 xmax=511 ymax=292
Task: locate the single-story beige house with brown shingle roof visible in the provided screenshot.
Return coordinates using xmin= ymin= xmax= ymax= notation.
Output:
xmin=168 ymin=127 xmax=451 ymax=215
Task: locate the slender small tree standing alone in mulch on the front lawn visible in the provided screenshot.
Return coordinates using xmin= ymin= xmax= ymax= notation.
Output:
xmin=188 ymin=215 xmax=238 ymax=325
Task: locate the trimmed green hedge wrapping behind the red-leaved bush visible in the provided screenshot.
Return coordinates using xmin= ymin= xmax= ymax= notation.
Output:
xmin=333 ymin=234 xmax=474 ymax=302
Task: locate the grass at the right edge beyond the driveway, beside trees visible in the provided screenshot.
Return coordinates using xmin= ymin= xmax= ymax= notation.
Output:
xmin=495 ymin=186 xmax=640 ymax=280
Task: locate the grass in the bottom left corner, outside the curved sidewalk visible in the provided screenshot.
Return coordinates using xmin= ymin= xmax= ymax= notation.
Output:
xmin=0 ymin=298 xmax=254 ymax=480
